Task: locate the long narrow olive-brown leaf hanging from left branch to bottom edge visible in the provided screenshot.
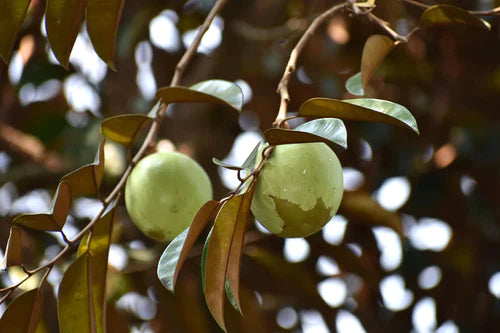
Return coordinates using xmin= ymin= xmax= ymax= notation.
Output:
xmin=78 ymin=201 xmax=116 ymax=332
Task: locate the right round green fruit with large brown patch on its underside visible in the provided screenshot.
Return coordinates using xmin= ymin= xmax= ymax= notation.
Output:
xmin=251 ymin=143 xmax=344 ymax=237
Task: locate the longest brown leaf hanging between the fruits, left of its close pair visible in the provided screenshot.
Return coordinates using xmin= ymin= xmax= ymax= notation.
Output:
xmin=205 ymin=194 xmax=244 ymax=331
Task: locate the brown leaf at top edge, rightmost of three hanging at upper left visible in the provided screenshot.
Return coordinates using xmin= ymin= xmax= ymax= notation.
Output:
xmin=87 ymin=0 xmax=125 ymax=70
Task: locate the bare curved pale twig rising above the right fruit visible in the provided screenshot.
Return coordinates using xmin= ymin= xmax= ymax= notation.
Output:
xmin=273 ymin=1 xmax=349 ymax=126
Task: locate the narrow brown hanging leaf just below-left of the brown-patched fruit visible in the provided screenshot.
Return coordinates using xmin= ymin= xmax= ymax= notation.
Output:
xmin=225 ymin=187 xmax=254 ymax=312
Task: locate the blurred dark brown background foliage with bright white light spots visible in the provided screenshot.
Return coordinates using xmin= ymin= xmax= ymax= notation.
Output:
xmin=0 ymin=0 xmax=500 ymax=333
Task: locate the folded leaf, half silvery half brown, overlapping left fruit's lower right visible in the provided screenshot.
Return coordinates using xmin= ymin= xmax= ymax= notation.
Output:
xmin=157 ymin=200 xmax=219 ymax=292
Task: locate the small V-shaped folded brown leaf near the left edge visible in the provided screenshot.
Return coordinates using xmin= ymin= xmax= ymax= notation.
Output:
xmin=13 ymin=180 xmax=71 ymax=231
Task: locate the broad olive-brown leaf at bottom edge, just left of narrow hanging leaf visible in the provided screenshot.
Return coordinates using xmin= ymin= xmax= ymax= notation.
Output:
xmin=57 ymin=252 xmax=97 ymax=333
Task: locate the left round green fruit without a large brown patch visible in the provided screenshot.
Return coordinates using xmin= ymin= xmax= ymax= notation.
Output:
xmin=125 ymin=152 xmax=212 ymax=242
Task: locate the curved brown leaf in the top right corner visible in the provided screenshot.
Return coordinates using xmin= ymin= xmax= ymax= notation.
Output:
xmin=420 ymin=5 xmax=490 ymax=30
